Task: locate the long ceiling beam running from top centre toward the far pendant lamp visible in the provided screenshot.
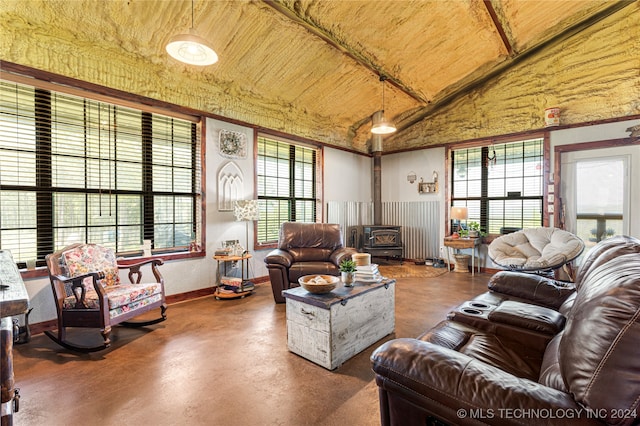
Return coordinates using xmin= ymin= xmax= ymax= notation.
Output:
xmin=262 ymin=0 xmax=428 ymax=104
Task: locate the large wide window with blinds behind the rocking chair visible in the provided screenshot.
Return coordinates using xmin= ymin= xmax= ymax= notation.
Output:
xmin=0 ymin=81 xmax=201 ymax=264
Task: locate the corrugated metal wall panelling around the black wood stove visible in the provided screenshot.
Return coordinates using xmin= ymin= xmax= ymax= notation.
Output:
xmin=327 ymin=201 xmax=440 ymax=259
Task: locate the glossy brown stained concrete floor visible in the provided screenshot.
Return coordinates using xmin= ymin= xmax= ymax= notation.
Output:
xmin=14 ymin=273 xmax=489 ymax=426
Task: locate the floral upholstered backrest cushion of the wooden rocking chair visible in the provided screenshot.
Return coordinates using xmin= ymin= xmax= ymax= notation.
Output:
xmin=62 ymin=244 xmax=120 ymax=290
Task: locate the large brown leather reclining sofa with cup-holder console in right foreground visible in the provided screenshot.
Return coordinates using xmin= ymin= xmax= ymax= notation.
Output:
xmin=371 ymin=237 xmax=640 ymax=426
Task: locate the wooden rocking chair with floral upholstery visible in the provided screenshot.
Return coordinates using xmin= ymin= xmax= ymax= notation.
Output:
xmin=45 ymin=244 xmax=167 ymax=353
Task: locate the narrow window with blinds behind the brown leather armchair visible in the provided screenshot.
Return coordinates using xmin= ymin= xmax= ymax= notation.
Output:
xmin=256 ymin=135 xmax=320 ymax=244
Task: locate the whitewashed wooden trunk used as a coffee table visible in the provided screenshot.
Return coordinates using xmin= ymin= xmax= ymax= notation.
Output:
xmin=282 ymin=278 xmax=396 ymax=370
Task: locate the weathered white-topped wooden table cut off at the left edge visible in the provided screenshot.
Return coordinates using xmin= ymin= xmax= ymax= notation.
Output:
xmin=0 ymin=250 xmax=29 ymax=426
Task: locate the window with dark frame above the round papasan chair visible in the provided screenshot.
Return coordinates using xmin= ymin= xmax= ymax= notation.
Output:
xmin=451 ymin=139 xmax=544 ymax=234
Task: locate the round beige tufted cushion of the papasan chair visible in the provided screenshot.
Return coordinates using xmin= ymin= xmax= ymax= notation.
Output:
xmin=489 ymin=227 xmax=584 ymax=271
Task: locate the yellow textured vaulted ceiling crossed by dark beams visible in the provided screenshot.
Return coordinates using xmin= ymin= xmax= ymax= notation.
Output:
xmin=4 ymin=0 xmax=624 ymax=150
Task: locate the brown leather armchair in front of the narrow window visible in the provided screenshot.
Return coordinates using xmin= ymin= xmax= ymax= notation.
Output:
xmin=264 ymin=222 xmax=358 ymax=303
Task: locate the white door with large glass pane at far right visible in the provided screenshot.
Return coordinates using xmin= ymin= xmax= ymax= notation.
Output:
xmin=560 ymin=148 xmax=631 ymax=255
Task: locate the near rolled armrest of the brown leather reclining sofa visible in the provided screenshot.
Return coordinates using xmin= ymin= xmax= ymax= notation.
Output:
xmin=371 ymin=338 xmax=599 ymax=425
